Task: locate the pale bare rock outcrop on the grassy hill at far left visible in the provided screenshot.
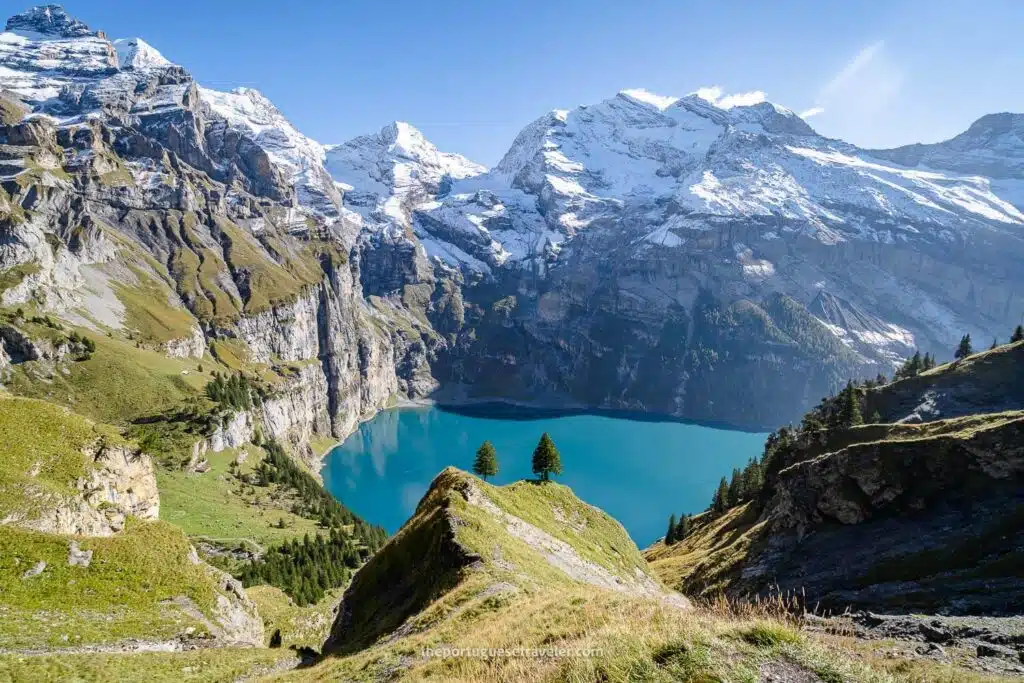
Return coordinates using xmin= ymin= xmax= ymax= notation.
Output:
xmin=22 ymin=446 xmax=160 ymax=536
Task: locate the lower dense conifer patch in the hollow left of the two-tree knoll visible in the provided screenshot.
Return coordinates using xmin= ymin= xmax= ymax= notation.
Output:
xmin=238 ymin=528 xmax=369 ymax=606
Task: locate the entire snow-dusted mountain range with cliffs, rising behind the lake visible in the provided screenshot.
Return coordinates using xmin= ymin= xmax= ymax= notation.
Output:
xmin=0 ymin=5 xmax=1024 ymax=436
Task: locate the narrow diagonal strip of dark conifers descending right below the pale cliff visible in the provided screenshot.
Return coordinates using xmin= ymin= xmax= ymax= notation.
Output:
xmin=256 ymin=441 xmax=387 ymax=551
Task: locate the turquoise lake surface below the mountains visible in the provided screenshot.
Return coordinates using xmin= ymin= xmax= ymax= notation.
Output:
xmin=322 ymin=405 xmax=766 ymax=548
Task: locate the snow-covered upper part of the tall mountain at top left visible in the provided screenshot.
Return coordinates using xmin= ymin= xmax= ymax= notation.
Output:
xmin=0 ymin=5 xmax=341 ymax=219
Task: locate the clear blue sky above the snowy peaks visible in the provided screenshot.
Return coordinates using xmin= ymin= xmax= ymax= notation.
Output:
xmin=49 ymin=0 xmax=1024 ymax=165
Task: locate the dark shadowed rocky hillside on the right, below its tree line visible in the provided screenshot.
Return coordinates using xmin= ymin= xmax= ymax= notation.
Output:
xmin=648 ymin=342 xmax=1024 ymax=613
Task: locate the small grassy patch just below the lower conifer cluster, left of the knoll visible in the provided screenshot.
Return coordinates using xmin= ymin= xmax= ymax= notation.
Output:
xmin=246 ymin=586 xmax=342 ymax=651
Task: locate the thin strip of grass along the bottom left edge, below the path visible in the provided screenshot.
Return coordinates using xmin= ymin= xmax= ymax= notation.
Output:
xmin=0 ymin=648 xmax=296 ymax=683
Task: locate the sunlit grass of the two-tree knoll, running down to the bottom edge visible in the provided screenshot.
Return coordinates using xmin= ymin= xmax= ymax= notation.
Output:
xmin=282 ymin=470 xmax=1007 ymax=682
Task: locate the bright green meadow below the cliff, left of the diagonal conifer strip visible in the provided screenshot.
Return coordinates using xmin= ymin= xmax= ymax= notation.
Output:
xmin=157 ymin=446 xmax=319 ymax=546
